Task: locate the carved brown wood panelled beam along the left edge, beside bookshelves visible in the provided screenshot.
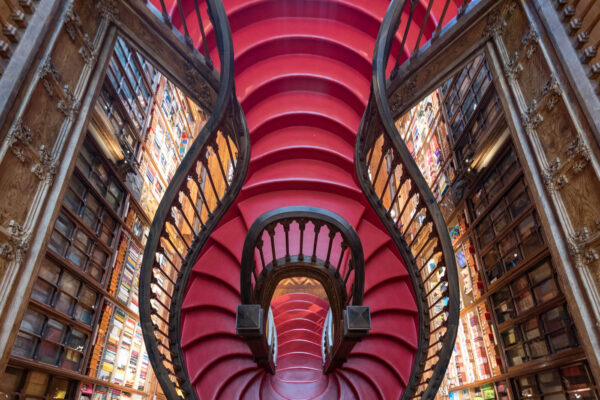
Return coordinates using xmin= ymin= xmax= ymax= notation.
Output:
xmin=0 ymin=0 xmax=108 ymax=368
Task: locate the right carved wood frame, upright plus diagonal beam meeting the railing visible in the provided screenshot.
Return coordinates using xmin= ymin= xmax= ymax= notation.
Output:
xmin=388 ymin=0 xmax=600 ymax=378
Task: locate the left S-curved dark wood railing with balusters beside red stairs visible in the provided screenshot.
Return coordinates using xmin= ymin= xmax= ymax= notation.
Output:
xmin=139 ymin=0 xmax=250 ymax=400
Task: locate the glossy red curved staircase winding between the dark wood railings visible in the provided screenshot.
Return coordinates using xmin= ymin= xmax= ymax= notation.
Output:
xmin=153 ymin=0 xmax=461 ymax=399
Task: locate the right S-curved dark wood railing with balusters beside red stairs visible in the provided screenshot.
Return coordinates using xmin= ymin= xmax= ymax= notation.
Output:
xmin=355 ymin=0 xmax=468 ymax=399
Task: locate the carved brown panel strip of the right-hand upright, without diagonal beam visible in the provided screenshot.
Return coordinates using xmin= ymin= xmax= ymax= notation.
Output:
xmin=493 ymin=1 xmax=600 ymax=312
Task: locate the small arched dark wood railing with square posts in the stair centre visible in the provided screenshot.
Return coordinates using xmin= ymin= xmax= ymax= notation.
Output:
xmin=237 ymin=207 xmax=370 ymax=373
